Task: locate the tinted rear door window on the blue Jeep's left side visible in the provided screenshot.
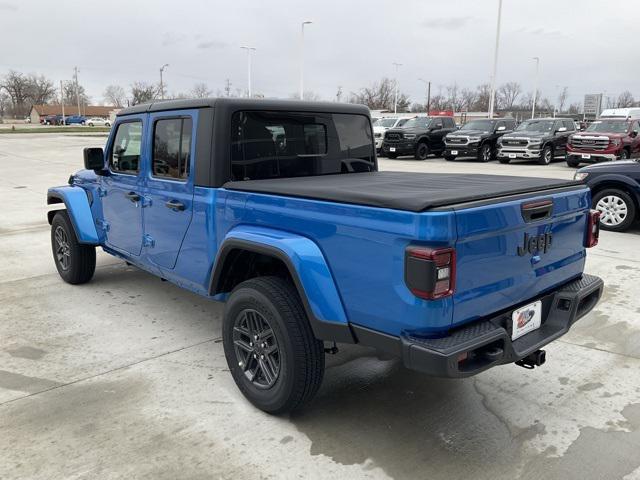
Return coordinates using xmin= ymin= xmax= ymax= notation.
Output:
xmin=151 ymin=118 xmax=192 ymax=180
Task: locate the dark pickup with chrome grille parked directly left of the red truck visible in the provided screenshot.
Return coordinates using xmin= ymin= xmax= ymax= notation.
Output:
xmin=498 ymin=118 xmax=576 ymax=165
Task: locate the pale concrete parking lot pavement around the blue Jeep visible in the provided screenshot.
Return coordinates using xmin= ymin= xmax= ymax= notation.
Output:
xmin=0 ymin=134 xmax=640 ymax=480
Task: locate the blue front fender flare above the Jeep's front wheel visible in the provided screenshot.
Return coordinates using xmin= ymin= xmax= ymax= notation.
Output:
xmin=47 ymin=186 xmax=99 ymax=245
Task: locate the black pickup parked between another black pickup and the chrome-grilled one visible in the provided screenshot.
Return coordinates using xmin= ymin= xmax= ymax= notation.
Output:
xmin=443 ymin=118 xmax=516 ymax=162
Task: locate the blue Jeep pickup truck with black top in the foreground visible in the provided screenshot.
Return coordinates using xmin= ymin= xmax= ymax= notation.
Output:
xmin=47 ymin=98 xmax=603 ymax=413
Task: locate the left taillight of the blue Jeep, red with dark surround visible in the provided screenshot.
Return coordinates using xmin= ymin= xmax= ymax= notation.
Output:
xmin=405 ymin=247 xmax=456 ymax=300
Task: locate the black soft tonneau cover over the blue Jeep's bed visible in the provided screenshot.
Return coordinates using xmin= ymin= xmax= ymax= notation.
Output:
xmin=223 ymin=172 xmax=583 ymax=212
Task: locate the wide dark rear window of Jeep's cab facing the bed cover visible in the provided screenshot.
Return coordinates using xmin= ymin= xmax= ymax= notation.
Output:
xmin=231 ymin=111 xmax=375 ymax=180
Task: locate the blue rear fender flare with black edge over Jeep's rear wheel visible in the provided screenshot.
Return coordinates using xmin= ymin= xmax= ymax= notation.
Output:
xmin=209 ymin=227 xmax=356 ymax=343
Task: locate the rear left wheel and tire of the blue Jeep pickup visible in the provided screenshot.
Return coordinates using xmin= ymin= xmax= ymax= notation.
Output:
xmin=222 ymin=277 xmax=324 ymax=414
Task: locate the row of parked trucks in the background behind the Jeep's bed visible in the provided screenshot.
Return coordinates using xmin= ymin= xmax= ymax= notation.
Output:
xmin=374 ymin=111 xmax=640 ymax=167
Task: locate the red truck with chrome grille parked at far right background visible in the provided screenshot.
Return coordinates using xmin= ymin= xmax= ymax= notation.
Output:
xmin=567 ymin=118 xmax=640 ymax=167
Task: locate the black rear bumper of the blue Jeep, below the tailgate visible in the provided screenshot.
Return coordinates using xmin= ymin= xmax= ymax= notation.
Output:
xmin=352 ymin=274 xmax=604 ymax=378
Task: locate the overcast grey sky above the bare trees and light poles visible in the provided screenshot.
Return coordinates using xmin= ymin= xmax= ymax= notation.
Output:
xmin=0 ymin=0 xmax=640 ymax=107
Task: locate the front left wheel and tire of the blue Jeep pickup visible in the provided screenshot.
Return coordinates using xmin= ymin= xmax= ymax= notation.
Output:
xmin=51 ymin=210 xmax=96 ymax=285
